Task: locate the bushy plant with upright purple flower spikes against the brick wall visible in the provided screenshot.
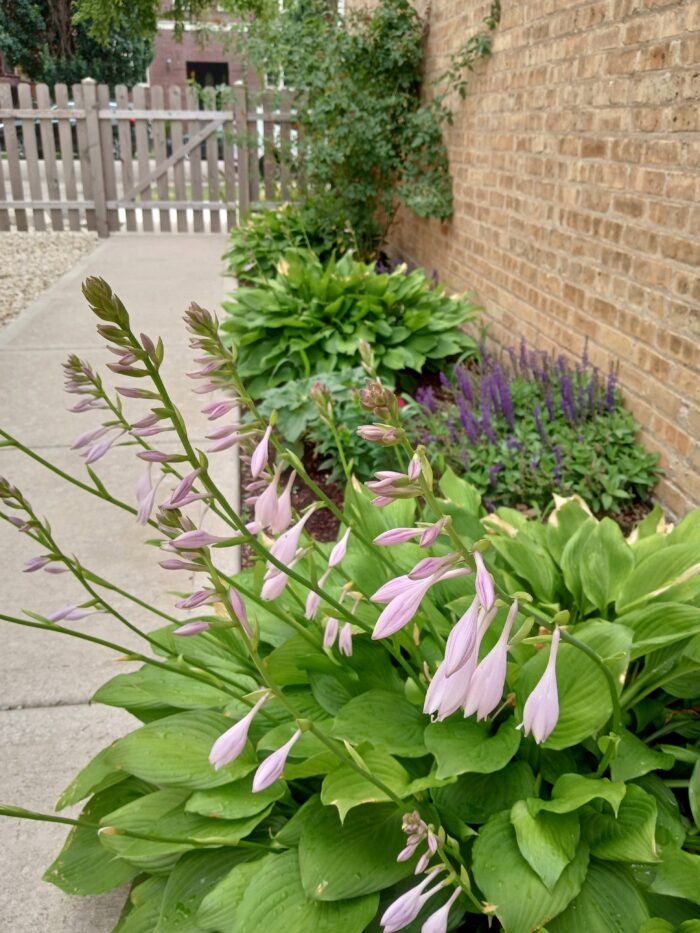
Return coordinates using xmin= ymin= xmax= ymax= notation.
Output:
xmin=412 ymin=343 xmax=660 ymax=514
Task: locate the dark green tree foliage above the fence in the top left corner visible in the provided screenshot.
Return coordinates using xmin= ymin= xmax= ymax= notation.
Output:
xmin=0 ymin=0 xmax=153 ymax=86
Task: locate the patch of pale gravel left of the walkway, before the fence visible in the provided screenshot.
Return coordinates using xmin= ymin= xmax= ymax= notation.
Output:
xmin=0 ymin=231 xmax=97 ymax=327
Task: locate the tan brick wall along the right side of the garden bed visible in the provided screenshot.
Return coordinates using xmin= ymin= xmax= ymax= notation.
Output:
xmin=356 ymin=0 xmax=700 ymax=516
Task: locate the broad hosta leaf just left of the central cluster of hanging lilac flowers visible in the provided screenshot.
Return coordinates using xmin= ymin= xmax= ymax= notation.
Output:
xmin=331 ymin=690 xmax=426 ymax=758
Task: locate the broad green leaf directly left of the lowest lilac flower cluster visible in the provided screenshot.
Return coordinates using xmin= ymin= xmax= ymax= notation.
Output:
xmin=299 ymin=804 xmax=413 ymax=901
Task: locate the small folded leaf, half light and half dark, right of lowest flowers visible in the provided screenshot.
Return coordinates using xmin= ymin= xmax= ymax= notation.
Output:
xmin=510 ymin=800 xmax=581 ymax=891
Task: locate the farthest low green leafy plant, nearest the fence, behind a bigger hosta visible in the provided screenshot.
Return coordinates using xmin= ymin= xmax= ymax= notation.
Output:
xmin=224 ymin=202 xmax=353 ymax=284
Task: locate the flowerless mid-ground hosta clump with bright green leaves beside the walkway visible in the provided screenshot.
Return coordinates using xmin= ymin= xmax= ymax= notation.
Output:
xmin=222 ymin=252 xmax=477 ymax=397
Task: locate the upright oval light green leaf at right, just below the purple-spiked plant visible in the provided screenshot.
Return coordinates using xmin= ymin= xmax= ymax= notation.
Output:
xmin=581 ymin=518 xmax=634 ymax=616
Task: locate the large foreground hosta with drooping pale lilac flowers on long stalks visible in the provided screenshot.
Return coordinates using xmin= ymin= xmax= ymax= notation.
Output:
xmin=0 ymin=280 xmax=700 ymax=933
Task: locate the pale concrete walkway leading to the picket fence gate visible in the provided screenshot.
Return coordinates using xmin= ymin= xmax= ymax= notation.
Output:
xmin=0 ymin=234 xmax=237 ymax=933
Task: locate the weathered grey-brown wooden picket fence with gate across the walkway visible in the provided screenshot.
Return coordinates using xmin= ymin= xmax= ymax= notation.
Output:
xmin=0 ymin=79 xmax=301 ymax=237
